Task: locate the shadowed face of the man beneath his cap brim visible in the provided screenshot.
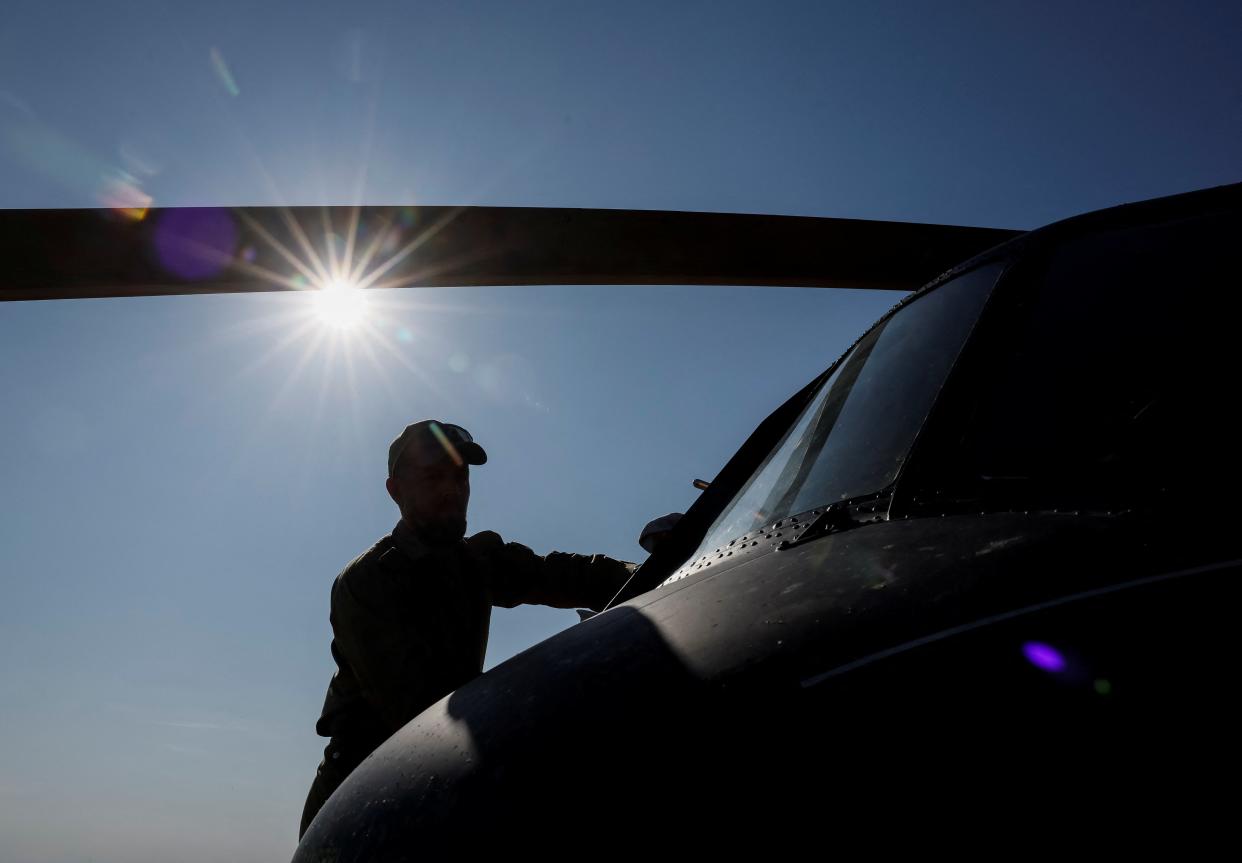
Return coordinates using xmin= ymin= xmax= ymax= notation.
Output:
xmin=388 ymin=458 xmax=469 ymax=543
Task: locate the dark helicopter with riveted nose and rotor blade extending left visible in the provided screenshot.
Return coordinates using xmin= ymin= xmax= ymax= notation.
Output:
xmin=0 ymin=184 xmax=1242 ymax=849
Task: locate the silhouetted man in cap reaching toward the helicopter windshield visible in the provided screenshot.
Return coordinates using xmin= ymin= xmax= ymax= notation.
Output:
xmin=298 ymin=420 xmax=635 ymax=837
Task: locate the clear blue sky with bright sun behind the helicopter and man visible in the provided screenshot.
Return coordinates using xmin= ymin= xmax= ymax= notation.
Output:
xmin=0 ymin=0 xmax=1242 ymax=863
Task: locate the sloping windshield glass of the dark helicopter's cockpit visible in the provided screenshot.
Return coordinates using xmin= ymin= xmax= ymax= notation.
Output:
xmin=691 ymin=263 xmax=1001 ymax=560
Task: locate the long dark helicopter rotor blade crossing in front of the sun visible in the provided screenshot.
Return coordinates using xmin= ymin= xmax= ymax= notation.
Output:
xmin=0 ymin=206 xmax=1021 ymax=300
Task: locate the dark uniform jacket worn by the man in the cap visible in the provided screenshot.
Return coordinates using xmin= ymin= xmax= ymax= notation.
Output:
xmin=315 ymin=522 xmax=635 ymax=766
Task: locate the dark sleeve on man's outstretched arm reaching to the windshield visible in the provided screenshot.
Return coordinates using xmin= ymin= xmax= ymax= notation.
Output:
xmin=467 ymin=530 xmax=636 ymax=611
